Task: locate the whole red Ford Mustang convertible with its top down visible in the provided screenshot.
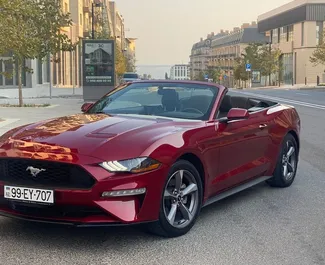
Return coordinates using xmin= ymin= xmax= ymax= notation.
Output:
xmin=0 ymin=80 xmax=300 ymax=237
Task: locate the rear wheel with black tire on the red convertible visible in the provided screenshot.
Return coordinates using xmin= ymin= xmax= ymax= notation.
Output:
xmin=267 ymin=133 xmax=299 ymax=188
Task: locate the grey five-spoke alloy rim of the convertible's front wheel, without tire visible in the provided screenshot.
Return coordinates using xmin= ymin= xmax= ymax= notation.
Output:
xmin=163 ymin=170 xmax=199 ymax=228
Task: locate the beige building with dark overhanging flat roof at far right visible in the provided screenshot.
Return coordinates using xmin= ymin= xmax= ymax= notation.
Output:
xmin=258 ymin=0 xmax=325 ymax=85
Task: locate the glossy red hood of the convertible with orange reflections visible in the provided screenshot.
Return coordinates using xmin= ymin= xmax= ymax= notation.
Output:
xmin=0 ymin=114 xmax=197 ymax=160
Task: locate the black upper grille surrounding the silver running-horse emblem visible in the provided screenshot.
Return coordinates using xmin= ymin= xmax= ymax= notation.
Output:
xmin=0 ymin=158 xmax=95 ymax=189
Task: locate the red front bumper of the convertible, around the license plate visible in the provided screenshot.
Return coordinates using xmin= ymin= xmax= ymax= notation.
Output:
xmin=0 ymin=162 xmax=168 ymax=227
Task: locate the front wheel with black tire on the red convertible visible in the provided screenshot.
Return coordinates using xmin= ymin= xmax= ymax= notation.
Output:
xmin=148 ymin=160 xmax=203 ymax=238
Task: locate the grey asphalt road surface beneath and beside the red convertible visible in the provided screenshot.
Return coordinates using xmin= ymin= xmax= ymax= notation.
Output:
xmin=0 ymin=90 xmax=325 ymax=265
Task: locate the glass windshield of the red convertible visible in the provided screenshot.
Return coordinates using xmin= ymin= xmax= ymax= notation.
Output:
xmin=87 ymin=83 xmax=218 ymax=120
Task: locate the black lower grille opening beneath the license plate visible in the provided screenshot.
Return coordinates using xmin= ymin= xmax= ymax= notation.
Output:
xmin=0 ymin=200 xmax=106 ymax=218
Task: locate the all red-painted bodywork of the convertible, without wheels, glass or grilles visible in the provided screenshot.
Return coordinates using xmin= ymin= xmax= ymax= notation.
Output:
xmin=0 ymin=80 xmax=300 ymax=225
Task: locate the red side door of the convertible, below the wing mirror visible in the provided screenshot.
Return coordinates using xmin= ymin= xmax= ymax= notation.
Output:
xmin=211 ymin=107 xmax=272 ymax=193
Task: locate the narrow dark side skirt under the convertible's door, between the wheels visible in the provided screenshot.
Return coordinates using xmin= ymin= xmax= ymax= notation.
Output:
xmin=202 ymin=176 xmax=273 ymax=207
